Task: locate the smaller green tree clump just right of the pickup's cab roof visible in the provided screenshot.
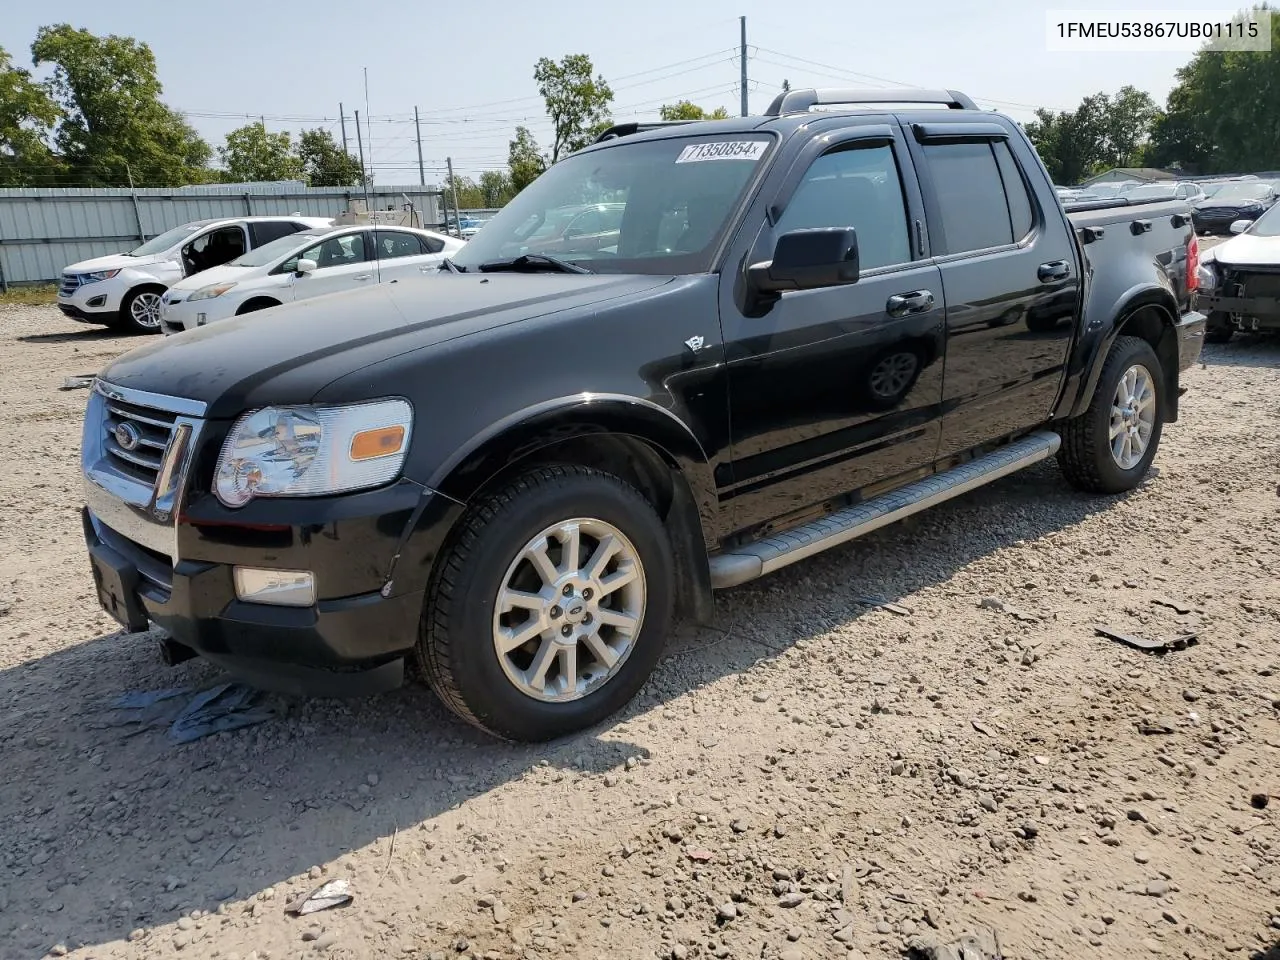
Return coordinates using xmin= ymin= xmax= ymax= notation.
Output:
xmin=1027 ymin=86 xmax=1160 ymax=184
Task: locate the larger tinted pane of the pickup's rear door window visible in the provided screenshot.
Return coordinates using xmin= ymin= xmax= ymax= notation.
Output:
xmin=924 ymin=141 xmax=1014 ymax=253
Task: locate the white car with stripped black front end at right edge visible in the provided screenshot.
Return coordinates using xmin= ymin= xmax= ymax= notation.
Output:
xmin=1196 ymin=199 xmax=1280 ymax=343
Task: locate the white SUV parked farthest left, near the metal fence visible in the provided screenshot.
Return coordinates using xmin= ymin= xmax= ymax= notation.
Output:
xmin=58 ymin=216 xmax=333 ymax=333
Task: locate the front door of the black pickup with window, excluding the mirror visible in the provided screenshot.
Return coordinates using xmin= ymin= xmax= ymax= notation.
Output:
xmin=721 ymin=118 xmax=945 ymax=529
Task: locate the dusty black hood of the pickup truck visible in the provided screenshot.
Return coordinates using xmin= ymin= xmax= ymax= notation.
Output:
xmin=99 ymin=273 xmax=672 ymax=419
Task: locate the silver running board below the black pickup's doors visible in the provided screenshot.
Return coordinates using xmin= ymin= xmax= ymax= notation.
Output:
xmin=710 ymin=430 xmax=1062 ymax=590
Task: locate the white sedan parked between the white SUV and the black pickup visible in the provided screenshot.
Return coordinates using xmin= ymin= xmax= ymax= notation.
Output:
xmin=160 ymin=227 xmax=466 ymax=334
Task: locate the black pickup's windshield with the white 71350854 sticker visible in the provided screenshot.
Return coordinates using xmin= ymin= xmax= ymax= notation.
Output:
xmin=453 ymin=133 xmax=773 ymax=275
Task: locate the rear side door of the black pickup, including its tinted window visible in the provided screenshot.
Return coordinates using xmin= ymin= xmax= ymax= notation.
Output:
xmin=908 ymin=122 xmax=1080 ymax=458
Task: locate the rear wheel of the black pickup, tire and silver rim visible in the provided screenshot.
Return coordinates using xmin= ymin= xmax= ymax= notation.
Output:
xmin=1057 ymin=337 xmax=1165 ymax=494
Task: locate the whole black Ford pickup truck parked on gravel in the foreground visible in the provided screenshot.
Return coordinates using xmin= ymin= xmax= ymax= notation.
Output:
xmin=82 ymin=90 xmax=1204 ymax=740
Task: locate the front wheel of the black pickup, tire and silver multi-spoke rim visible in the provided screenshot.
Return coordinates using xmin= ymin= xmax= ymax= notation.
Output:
xmin=415 ymin=465 xmax=675 ymax=742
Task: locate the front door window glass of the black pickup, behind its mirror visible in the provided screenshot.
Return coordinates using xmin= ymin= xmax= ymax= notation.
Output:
xmin=774 ymin=145 xmax=911 ymax=270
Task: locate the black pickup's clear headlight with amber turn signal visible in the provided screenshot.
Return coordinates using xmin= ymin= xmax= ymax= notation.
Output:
xmin=214 ymin=399 xmax=413 ymax=507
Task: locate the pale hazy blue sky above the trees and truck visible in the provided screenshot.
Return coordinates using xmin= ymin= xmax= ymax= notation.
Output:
xmin=0 ymin=0 xmax=1213 ymax=184
